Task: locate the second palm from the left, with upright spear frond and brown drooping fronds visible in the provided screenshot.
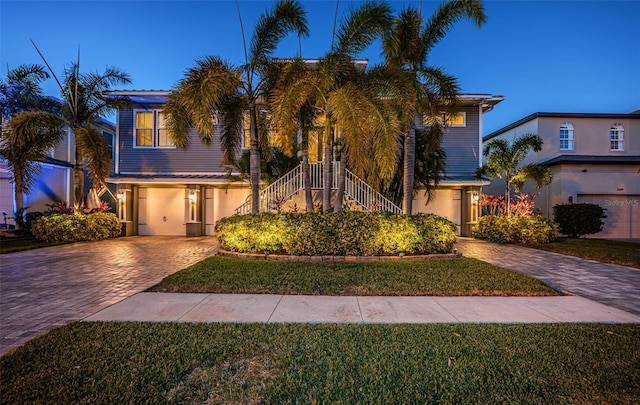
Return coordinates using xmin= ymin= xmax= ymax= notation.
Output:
xmin=32 ymin=41 xmax=131 ymax=206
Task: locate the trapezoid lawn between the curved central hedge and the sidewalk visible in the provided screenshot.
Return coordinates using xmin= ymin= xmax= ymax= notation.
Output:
xmin=149 ymin=256 xmax=557 ymax=295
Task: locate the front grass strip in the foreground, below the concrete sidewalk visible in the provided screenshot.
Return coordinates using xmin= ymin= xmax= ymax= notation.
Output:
xmin=0 ymin=322 xmax=640 ymax=404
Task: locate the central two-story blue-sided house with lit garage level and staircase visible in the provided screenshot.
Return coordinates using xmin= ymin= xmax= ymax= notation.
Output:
xmin=107 ymin=90 xmax=503 ymax=236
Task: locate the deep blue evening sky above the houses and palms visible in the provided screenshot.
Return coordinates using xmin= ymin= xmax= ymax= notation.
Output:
xmin=0 ymin=0 xmax=640 ymax=135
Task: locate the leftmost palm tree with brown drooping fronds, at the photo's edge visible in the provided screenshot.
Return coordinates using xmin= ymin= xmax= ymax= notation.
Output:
xmin=0 ymin=65 xmax=64 ymax=229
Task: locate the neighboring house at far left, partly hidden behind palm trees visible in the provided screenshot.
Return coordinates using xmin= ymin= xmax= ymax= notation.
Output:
xmin=0 ymin=119 xmax=115 ymax=225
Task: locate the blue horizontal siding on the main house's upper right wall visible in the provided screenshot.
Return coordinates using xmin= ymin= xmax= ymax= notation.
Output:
xmin=442 ymin=107 xmax=482 ymax=176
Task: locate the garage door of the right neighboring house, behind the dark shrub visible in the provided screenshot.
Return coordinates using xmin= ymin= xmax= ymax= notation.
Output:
xmin=578 ymin=194 xmax=640 ymax=239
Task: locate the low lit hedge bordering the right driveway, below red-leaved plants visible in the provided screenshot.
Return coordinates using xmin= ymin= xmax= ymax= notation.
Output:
xmin=471 ymin=215 xmax=556 ymax=244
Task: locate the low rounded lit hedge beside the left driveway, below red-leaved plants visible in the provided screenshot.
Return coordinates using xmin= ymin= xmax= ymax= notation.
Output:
xmin=31 ymin=212 xmax=121 ymax=242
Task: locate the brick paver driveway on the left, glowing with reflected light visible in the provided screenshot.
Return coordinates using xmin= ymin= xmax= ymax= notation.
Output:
xmin=0 ymin=236 xmax=218 ymax=355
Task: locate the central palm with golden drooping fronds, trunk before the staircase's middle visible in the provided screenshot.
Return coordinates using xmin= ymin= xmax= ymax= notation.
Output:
xmin=271 ymin=1 xmax=395 ymax=212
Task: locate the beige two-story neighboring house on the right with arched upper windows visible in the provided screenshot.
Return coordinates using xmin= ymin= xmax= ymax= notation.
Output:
xmin=483 ymin=110 xmax=640 ymax=238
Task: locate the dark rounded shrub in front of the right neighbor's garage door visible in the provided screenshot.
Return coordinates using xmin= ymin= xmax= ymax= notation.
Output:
xmin=553 ymin=204 xmax=607 ymax=238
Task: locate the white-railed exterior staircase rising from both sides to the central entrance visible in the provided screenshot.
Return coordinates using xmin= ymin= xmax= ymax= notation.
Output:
xmin=235 ymin=162 xmax=402 ymax=214
